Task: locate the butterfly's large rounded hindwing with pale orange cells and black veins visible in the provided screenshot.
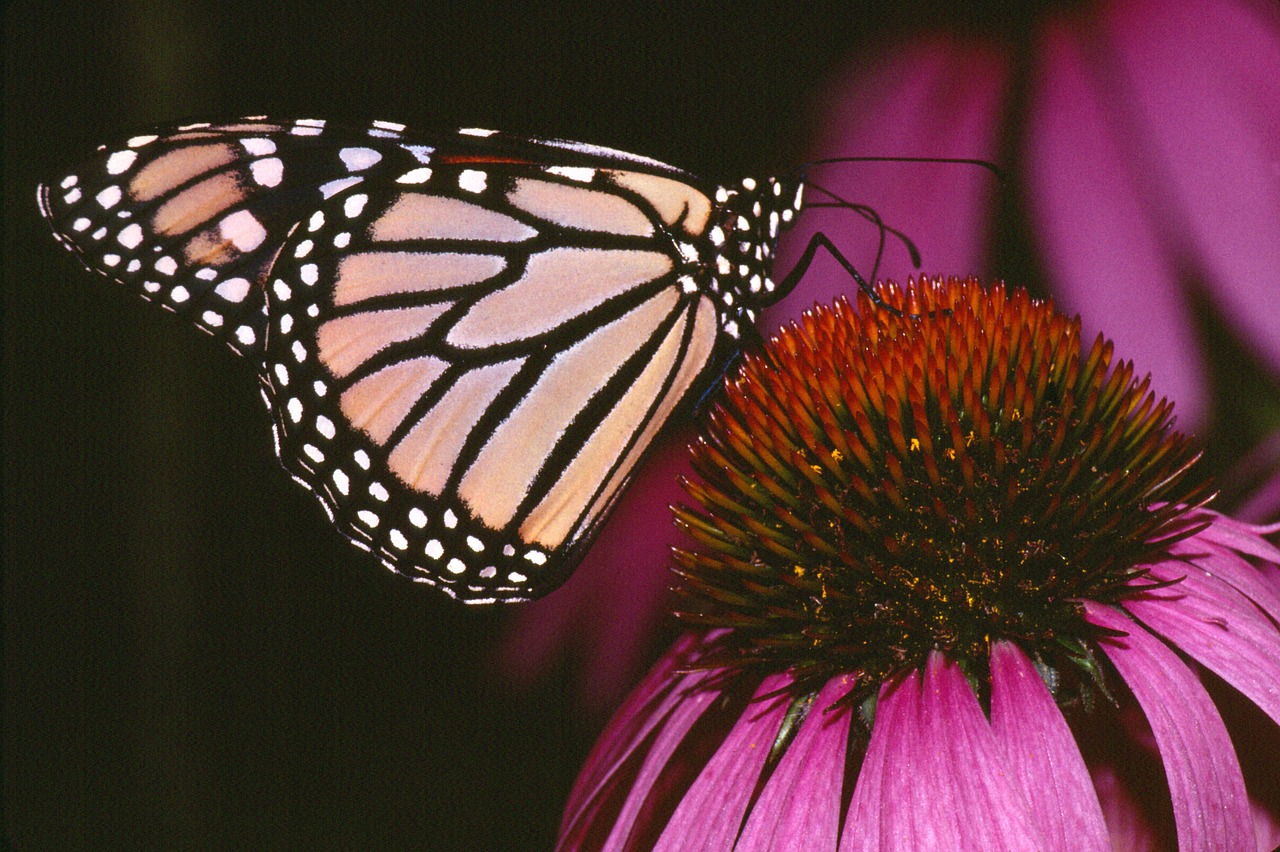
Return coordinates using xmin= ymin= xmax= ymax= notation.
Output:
xmin=262 ymin=155 xmax=724 ymax=603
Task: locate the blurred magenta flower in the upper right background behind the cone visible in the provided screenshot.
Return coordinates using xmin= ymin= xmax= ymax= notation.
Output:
xmin=769 ymin=0 xmax=1280 ymax=431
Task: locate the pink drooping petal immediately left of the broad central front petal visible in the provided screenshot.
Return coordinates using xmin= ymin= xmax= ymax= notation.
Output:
xmin=735 ymin=677 xmax=850 ymax=852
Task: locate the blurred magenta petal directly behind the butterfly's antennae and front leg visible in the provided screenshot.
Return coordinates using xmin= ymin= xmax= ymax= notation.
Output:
xmin=763 ymin=35 xmax=1009 ymax=324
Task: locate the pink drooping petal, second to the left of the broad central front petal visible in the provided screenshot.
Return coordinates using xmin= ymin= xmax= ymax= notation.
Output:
xmin=654 ymin=674 xmax=793 ymax=852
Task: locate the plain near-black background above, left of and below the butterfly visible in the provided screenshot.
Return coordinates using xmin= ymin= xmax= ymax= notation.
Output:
xmin=4 ymin=0 xmax=885 ymax=849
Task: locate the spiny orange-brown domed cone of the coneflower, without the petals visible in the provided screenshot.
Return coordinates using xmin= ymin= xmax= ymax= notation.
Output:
xmin=676 ymin=279 xmax=1204 ymax=684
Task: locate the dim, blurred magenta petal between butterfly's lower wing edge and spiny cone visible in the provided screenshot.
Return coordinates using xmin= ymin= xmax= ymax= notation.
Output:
xmin=494 ymin=430 xmax=691 ymax=715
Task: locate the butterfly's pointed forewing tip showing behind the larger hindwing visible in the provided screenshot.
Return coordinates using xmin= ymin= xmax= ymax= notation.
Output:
xmin=40 ymin=118 xmax=419 ymax=359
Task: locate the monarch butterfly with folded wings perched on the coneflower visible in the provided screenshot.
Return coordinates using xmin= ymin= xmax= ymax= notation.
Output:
xmin=38 ymin=116 xmax=839 ymax=603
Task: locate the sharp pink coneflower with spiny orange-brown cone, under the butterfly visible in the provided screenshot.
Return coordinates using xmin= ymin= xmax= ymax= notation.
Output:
xmin=561 ymin=279 xmax=1280 ymax=851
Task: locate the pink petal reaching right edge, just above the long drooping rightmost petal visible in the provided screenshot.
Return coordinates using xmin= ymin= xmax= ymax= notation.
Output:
xmin=1124 ymin=562 xmax=1280 ymax=724
